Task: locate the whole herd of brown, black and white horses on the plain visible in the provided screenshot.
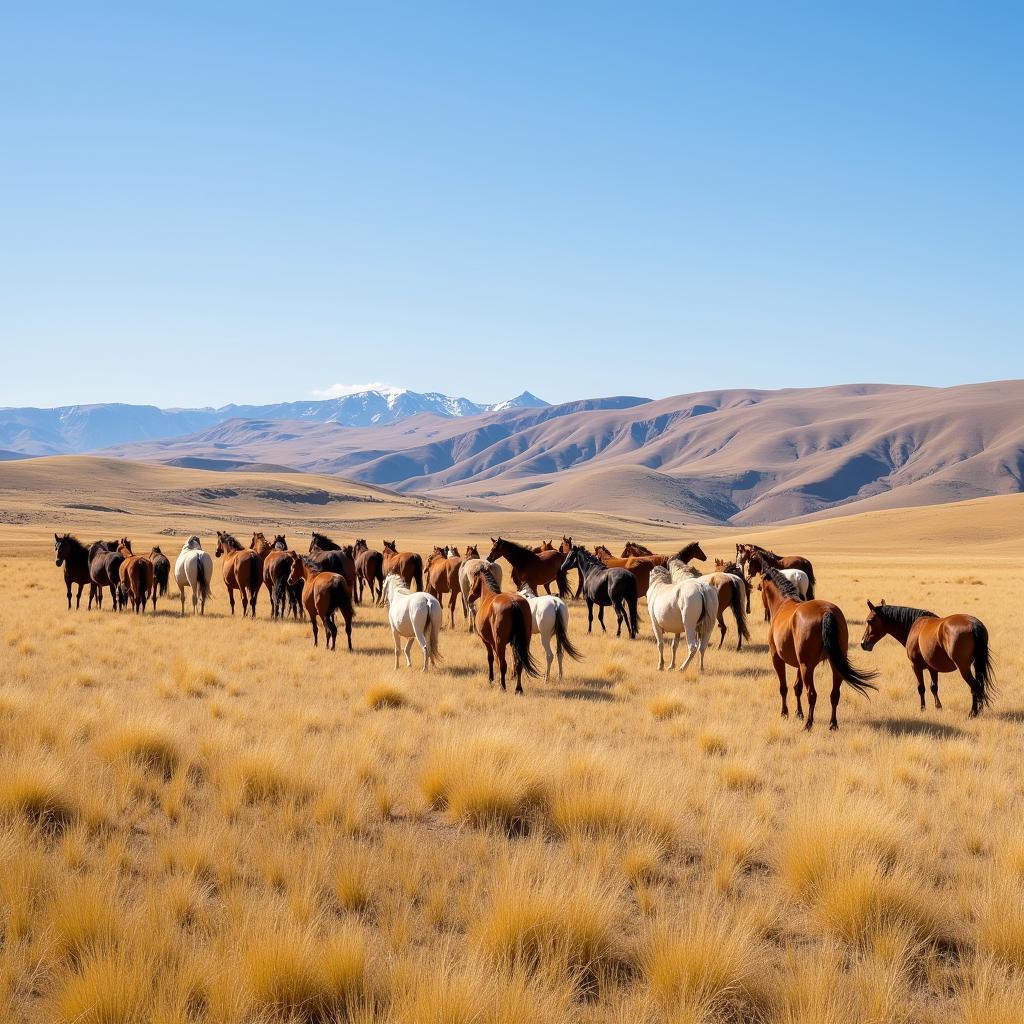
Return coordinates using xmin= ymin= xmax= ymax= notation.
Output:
xmin=54 ymin=531 xmax=995 ymax=729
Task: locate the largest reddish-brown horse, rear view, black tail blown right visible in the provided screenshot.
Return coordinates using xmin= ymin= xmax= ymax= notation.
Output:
xmin=761 ymin=565 xmax=878 ymax=729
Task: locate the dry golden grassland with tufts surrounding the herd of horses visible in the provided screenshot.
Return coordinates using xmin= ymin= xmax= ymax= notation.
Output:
xmin=0 ymin=468 xmax=1024 ymax=1024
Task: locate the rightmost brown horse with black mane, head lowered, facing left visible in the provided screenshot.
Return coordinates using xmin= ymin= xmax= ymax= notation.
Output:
xmin=860 ymin=601 xmax=995 ymax=718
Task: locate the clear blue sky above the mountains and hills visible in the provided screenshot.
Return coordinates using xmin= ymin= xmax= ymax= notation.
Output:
xmin=0 ymin=2 xmax=1024 ymax=406
